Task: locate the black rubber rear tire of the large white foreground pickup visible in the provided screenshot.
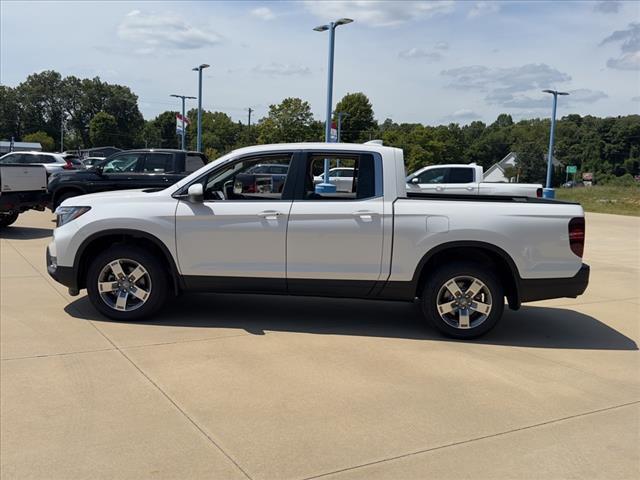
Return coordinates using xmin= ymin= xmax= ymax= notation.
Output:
xmin=421 ymin=262 xmax=504 ymax=339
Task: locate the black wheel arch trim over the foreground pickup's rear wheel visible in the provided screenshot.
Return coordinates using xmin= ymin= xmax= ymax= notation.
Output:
xmin=412 ymin=241 xmax=520 ymax=310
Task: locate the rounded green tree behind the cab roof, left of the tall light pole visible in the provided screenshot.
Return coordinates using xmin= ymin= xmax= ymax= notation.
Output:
xmin=256 ymin=98 xmax=318 ymax=143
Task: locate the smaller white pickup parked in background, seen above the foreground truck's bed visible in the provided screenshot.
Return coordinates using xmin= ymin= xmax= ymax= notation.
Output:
xmin=407 ymin=163 xmax=542 ymax=198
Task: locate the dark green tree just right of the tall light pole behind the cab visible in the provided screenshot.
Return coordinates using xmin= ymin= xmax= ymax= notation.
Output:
xmin=334 ymin=92 xmax=377 ymax=143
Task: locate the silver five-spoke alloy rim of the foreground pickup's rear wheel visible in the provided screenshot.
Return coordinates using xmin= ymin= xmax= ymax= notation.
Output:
xmin=436 ymin=276 xmax=492 ymax=329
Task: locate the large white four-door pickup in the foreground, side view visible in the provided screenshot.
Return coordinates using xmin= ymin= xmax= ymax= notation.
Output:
xmin=46 ymin=143 xmax=589 ymax=338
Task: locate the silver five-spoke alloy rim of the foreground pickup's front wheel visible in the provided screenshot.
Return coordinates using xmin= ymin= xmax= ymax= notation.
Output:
xmin=98 ymin=258 xmax=151 ymax=312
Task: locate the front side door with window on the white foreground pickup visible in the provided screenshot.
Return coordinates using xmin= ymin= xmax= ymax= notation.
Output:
xmin=176 ymin=152 xmax=293 ymax=293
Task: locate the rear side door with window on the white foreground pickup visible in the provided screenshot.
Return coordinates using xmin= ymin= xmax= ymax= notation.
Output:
xmin=287 ymin=151 xmax=384 ymax=296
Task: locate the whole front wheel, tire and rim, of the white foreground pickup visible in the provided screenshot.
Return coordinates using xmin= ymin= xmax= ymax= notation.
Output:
xmin=86 ymin=245 xmax=169 ymax=321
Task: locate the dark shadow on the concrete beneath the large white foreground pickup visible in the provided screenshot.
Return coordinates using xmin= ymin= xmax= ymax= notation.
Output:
xmin=65 ymin=294 xmax=638 ymax=350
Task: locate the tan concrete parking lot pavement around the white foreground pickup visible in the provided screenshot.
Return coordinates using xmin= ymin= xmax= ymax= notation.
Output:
xmin=0 ymin=212 xmax=640 ymax=480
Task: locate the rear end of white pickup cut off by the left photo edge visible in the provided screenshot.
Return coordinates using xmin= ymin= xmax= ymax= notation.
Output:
xmin=0 ymin=163 xmax=47 ymax=228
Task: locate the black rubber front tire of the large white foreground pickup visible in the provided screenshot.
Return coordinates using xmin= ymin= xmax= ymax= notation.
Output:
xmin=86 ymin=245 xmax=169 ymax=321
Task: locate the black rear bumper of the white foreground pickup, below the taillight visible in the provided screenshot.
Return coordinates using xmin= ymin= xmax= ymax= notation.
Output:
xmin=518 ymin=263 xmax=590 ymax=303
